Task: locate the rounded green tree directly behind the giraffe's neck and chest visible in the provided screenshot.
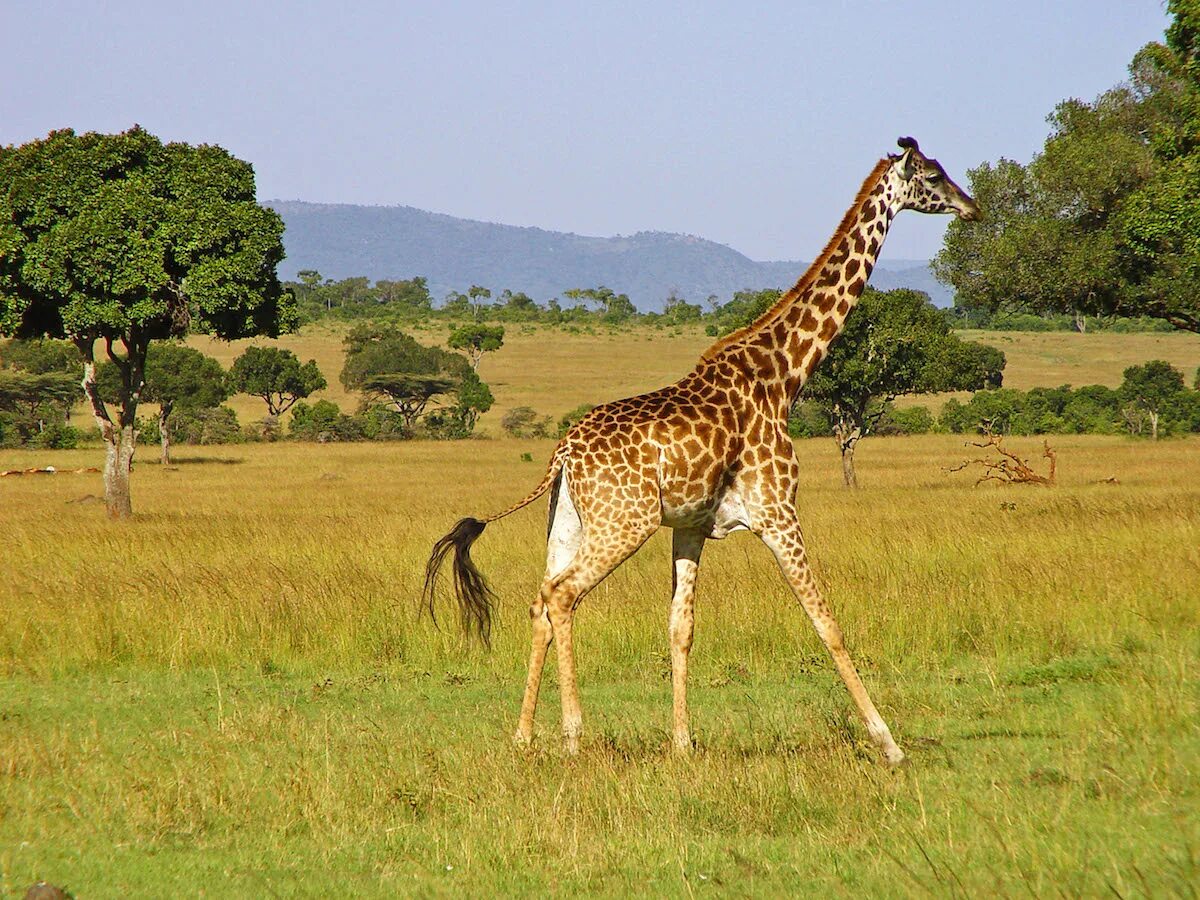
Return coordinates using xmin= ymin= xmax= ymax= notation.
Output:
xmin=800 ymin=288 xmax=1004 ymax=487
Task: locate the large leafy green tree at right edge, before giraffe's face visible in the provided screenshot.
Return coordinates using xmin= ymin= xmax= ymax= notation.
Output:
xmin=935 ymin=0 xmax=1200 ymax=331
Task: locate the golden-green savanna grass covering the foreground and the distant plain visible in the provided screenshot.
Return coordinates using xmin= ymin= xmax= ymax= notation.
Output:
xmin=0 ymin=328 xmax=1200 ymax=898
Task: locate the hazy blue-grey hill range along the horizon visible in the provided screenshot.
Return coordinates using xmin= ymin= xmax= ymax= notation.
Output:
xmin=264 ymin=200 xmax=952 ymax=311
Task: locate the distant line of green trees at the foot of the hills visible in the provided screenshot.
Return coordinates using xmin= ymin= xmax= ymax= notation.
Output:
xmin=292 ymin=270 xmax=1174 ymax=336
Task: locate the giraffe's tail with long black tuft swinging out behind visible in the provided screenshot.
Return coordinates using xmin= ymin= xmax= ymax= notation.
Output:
xmin=421 ymin=440 xmax=566 ymax=647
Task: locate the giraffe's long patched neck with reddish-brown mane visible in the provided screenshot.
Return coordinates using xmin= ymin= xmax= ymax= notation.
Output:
xmin=702 ymin=160 xmax=901 ymax=415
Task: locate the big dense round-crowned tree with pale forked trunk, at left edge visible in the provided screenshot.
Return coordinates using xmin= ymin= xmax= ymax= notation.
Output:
xmin=0 ymin=126 xmax=295 ymax=517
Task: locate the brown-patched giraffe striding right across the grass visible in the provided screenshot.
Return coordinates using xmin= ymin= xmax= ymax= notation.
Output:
xmin=424 ymin=138 xmax=979 ymax=766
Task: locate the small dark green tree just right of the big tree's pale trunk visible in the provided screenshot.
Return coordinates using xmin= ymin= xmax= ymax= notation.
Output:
xmin=96 ymin=342 xmax=229 ymax=466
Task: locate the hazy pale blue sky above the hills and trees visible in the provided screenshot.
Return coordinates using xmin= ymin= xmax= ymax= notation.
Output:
xmin=0 ymin=0 xmax=1166 ymax=259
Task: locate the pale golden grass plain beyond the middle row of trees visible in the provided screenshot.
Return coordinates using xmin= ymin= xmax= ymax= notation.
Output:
xmin=182 ymin=324 xmax=1200 ymax=434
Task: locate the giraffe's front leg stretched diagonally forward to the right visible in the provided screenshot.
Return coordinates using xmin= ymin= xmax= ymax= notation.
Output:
xmin=758 ymin=520 xmax=904 ymax=766
